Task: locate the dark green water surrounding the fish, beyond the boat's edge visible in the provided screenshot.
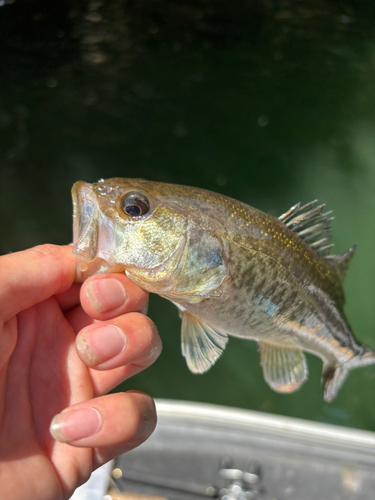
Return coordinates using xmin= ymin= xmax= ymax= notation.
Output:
xmin=0 ymin=0 xmax=375 ymax=430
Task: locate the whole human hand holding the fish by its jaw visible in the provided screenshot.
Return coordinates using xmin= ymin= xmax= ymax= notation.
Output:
xmin=0 ymin=245 xmax=161 ymax=500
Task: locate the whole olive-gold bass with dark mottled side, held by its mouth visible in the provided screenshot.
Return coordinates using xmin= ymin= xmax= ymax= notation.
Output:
xmin=72 ymin=178 xmax=375 ymax=401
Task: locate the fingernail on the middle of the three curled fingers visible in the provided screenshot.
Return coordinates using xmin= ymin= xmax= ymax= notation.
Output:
xmin=76 ymin=325 xmax=126 ymax=366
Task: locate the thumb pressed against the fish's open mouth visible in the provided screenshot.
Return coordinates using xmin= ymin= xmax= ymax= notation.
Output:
xmin=0 ymin=245 xmax=76 ymax=322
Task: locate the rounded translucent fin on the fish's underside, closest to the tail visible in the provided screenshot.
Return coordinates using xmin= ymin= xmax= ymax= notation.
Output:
xmin=259 ymin=342 xmax=307 ymax=392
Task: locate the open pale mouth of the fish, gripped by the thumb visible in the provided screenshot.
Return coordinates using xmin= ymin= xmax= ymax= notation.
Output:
xmin=72 ymin=181 xmax=124 ymax=283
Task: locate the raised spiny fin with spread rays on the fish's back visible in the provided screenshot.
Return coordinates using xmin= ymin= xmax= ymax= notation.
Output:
xmin=279 ymin=200 xmax=333 ymax=257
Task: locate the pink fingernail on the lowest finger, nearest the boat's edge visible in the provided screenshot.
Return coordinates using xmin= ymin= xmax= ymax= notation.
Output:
xmin=50 ymin=408 xmax=102 ymax=443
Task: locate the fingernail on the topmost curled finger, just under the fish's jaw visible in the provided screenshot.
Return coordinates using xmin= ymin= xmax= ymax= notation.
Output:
xmin=85 ymin=278 xmax=126 ymax=313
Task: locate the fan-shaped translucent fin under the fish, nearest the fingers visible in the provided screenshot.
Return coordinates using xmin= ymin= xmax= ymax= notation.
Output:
xmin=181 ymin=311 xmax=228 ymax=373
